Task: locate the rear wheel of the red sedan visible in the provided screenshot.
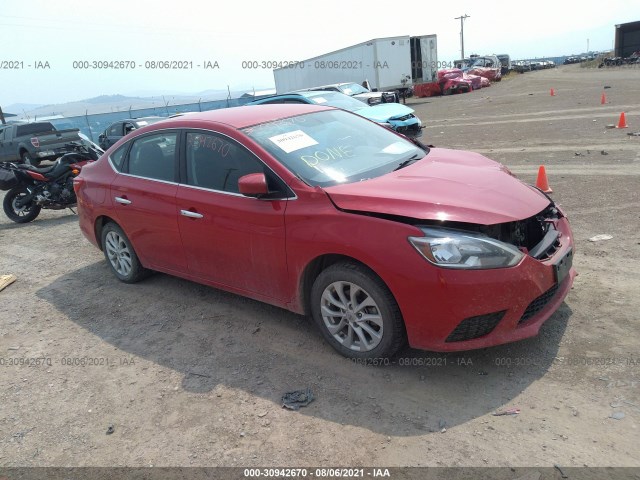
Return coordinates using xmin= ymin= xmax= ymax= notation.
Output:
xmin=102 ymin=223 xmax=149 ymax=283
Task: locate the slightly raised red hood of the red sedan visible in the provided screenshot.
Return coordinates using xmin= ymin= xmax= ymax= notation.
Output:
xmin=324 ymin=148 xmax=549 ymax=225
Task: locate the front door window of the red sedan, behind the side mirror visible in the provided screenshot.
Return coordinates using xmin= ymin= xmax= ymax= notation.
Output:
xmin=186 ymin=132 xmax=267 ymax=193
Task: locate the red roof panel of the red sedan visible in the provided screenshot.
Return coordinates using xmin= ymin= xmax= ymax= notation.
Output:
xmin=150 ymin=103 xmax=330 ymax=128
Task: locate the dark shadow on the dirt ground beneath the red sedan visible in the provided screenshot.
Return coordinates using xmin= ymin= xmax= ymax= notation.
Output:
xmin=37 ymin=262 xmax=572 ymax=436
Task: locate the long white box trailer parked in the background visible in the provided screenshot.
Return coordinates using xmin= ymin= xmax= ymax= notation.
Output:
xmin=273 ymin=35 xmax=441 ymax=94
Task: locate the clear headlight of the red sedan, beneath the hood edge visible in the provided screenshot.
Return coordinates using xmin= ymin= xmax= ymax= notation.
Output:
xmin=409 ymin=228 xmax=524 ymax=269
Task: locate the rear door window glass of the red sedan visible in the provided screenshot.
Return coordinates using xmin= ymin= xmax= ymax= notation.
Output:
xmin=127 ymin=132 xmax=178 ymax=182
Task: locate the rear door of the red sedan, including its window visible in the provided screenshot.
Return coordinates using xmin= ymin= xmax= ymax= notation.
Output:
xmin=110 ymin=129 xmax=187 ymax=272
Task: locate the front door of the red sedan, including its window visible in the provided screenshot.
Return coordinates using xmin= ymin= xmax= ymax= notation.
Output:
xmin=176 ymin=130 xmax=289 ymax=300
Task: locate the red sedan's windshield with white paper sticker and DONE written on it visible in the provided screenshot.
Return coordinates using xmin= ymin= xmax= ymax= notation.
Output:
xmin=243 ymin=110 xmax=428 ymax=187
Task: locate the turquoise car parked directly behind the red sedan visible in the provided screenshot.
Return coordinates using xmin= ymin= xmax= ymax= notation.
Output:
xmin=248 ymin=91 xmax=422 ymax=137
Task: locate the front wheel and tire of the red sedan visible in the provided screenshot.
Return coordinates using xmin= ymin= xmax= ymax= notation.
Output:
xmin=311 ymin=262 xmax=406 ymax=359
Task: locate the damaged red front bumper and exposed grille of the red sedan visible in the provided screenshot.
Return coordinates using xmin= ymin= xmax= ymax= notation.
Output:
xmin=394 ymin=204 xmax=576 ymax=351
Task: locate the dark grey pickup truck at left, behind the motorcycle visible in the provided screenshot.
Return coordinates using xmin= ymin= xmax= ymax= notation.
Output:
xmin=0 ymin=122 xmax=80 ymax=166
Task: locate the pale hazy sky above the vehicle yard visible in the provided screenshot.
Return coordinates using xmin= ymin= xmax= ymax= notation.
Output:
xmin=0 ymin=0 xmax=640 ymax=106
